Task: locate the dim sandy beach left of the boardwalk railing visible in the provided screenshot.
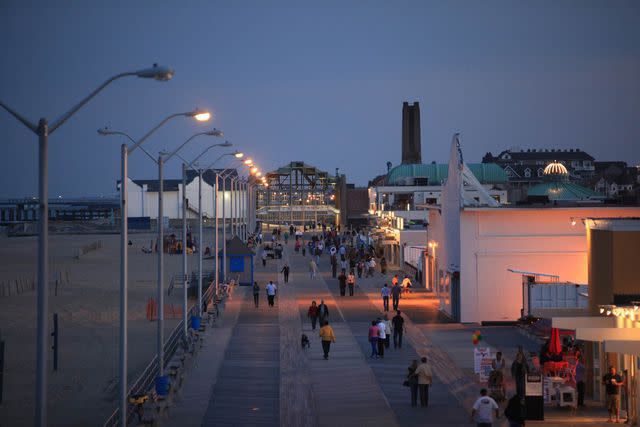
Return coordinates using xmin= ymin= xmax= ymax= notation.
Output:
xmin=0 ymin=229 xmax=220 ymax=426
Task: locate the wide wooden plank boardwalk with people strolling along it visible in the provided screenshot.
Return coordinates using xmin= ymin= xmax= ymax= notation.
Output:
xmin=168 ymin=239 xmax=468 ymax=426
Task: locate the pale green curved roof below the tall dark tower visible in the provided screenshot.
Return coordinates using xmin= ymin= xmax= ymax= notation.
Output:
xmin=387 ymin=163 xmax=507 ymax=185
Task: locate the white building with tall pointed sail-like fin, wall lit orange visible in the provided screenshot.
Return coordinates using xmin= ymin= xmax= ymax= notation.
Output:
xmin=427 ymin=138 xmax=640 ymax=322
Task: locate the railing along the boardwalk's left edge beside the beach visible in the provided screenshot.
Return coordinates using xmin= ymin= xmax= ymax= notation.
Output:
xmin=104 ymin=283 xmax=215 ymax=427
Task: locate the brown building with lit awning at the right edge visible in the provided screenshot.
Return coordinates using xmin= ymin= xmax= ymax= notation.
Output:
xmin=552 ymin=221 xmax=640 ymax=425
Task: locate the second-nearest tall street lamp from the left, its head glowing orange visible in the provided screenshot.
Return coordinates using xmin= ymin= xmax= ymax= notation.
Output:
xmin=98 ymin=110 xmax=210 ymax=426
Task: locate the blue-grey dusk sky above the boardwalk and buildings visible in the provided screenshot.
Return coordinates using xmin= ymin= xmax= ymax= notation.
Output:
xmin=0 ymin=0 xmax=640 ymax=197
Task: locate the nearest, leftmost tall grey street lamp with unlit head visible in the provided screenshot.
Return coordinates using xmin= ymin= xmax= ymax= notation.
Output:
xmin=0 ymin=64 xmax=174 ymax=426
